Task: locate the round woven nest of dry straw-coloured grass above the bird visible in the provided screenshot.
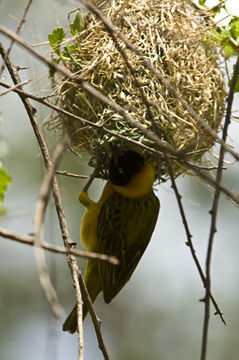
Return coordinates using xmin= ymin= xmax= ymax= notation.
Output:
xmin=51 ymin=0 xmax=225 ymax=178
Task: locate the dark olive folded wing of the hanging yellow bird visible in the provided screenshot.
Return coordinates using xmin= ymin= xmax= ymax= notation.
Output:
xmin=98 ymin=191 xmax=159 ymax=303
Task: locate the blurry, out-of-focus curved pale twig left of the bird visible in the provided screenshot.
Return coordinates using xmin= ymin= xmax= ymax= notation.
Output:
xmin=34 ymin=141 xmax=67 ymax=318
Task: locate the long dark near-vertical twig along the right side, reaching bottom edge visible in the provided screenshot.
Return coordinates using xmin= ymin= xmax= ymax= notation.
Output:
xmin=201 ymin=55 xmax=239 ymax=360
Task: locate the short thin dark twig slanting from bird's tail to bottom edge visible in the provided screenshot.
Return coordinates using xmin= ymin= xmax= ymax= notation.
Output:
xmin=78 ymin=271 xmax=110 ymax=360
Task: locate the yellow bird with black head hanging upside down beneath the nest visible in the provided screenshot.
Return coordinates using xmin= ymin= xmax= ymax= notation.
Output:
xmin=63 ymin=149 xmax=160 ymax=333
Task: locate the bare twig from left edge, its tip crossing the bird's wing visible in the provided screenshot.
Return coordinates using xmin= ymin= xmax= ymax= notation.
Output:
xmin=0 ymin=227 xmax=119 ymax=265
